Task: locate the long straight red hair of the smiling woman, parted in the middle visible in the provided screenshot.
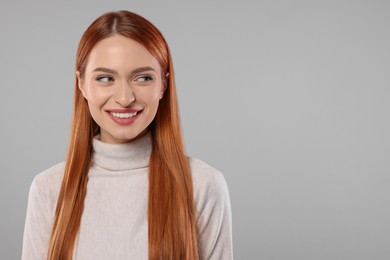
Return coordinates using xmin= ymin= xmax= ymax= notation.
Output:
xmin=48 ymin=11 xmax=198 ymax=260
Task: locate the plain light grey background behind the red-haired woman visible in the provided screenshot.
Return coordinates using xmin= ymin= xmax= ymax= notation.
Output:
xmin=0 ymin=0 xmax=390 ymax=260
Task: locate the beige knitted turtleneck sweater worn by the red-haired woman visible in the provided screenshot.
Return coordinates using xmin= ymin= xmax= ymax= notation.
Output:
xmin=22 ymin=135 xmax=233 ymax=260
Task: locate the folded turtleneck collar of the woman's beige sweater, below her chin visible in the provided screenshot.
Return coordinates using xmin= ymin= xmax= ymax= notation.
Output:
xmin=92 ymin=133 xmax=152 ymax=171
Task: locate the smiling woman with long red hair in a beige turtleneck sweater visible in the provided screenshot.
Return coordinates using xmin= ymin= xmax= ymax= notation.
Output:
xmin=22 ymin=11 xmax=233 ymax=260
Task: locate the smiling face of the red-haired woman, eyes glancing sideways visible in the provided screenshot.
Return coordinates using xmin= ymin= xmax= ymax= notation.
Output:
xmin=77 ymin=35 xmax=165 ymax=143
